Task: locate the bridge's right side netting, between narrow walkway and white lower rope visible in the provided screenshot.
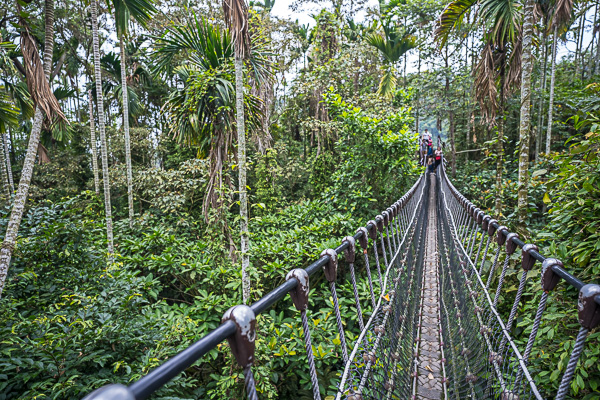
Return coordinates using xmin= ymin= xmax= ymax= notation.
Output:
xmin=440 ymin=171 xmax=542 ymax=399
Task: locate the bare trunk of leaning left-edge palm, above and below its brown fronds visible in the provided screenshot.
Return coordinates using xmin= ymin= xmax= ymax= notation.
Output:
xmin=0 ymin=0 xmax=54 ymax=297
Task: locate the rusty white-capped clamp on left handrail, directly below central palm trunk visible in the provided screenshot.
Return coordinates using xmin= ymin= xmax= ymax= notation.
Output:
xmin=221 ymin=304 xmax=256 ymax=368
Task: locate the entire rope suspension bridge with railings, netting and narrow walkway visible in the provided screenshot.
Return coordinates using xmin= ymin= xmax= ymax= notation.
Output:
xmin=86 ymin=167 xmax=600 ymax=400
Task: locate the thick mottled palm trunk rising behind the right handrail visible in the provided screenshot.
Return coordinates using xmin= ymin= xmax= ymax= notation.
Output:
xmin=517 ymin=0 xmax=534 ymax=233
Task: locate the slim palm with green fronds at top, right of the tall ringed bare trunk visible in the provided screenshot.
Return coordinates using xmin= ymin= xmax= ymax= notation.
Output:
xmin=113 ymin=0 xmax=156 ymax=227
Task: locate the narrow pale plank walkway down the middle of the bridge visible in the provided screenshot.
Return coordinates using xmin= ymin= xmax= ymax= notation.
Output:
xmin=413 ymin=174 xmax=445 ymax=400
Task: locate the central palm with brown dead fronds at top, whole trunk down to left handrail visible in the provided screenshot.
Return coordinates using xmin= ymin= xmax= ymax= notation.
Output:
xmin=223 ymin=0 xmax=250 ymax=304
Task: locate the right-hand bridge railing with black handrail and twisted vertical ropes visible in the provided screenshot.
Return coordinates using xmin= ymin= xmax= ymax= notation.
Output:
xmin=440 ymin=161 xmax=600 ymax=400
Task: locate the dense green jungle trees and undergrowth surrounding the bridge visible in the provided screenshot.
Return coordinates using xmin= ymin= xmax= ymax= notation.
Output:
xmin=0 ymin=0 xmax=600 ymax=400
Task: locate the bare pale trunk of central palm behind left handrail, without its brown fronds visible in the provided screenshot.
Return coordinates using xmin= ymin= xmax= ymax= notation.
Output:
xmin=235 ymin=55 xmax=250 ymax=304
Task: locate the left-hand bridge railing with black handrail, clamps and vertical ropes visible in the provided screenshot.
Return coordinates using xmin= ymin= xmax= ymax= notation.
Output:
xmin=85 ymin=176 xmax=425 ymax=400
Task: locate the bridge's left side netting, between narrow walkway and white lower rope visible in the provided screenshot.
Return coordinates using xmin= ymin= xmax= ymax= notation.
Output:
xmin=337 ymin=177 xmax=427 ymax=400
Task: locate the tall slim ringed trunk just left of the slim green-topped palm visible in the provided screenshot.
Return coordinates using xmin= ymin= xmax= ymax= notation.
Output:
xmin=90 ymin=0 xmax=115 ymax=256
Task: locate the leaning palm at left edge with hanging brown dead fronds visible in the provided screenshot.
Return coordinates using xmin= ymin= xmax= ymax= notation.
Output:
xmin=0 ymin=0 xmax=65 ymax=296
